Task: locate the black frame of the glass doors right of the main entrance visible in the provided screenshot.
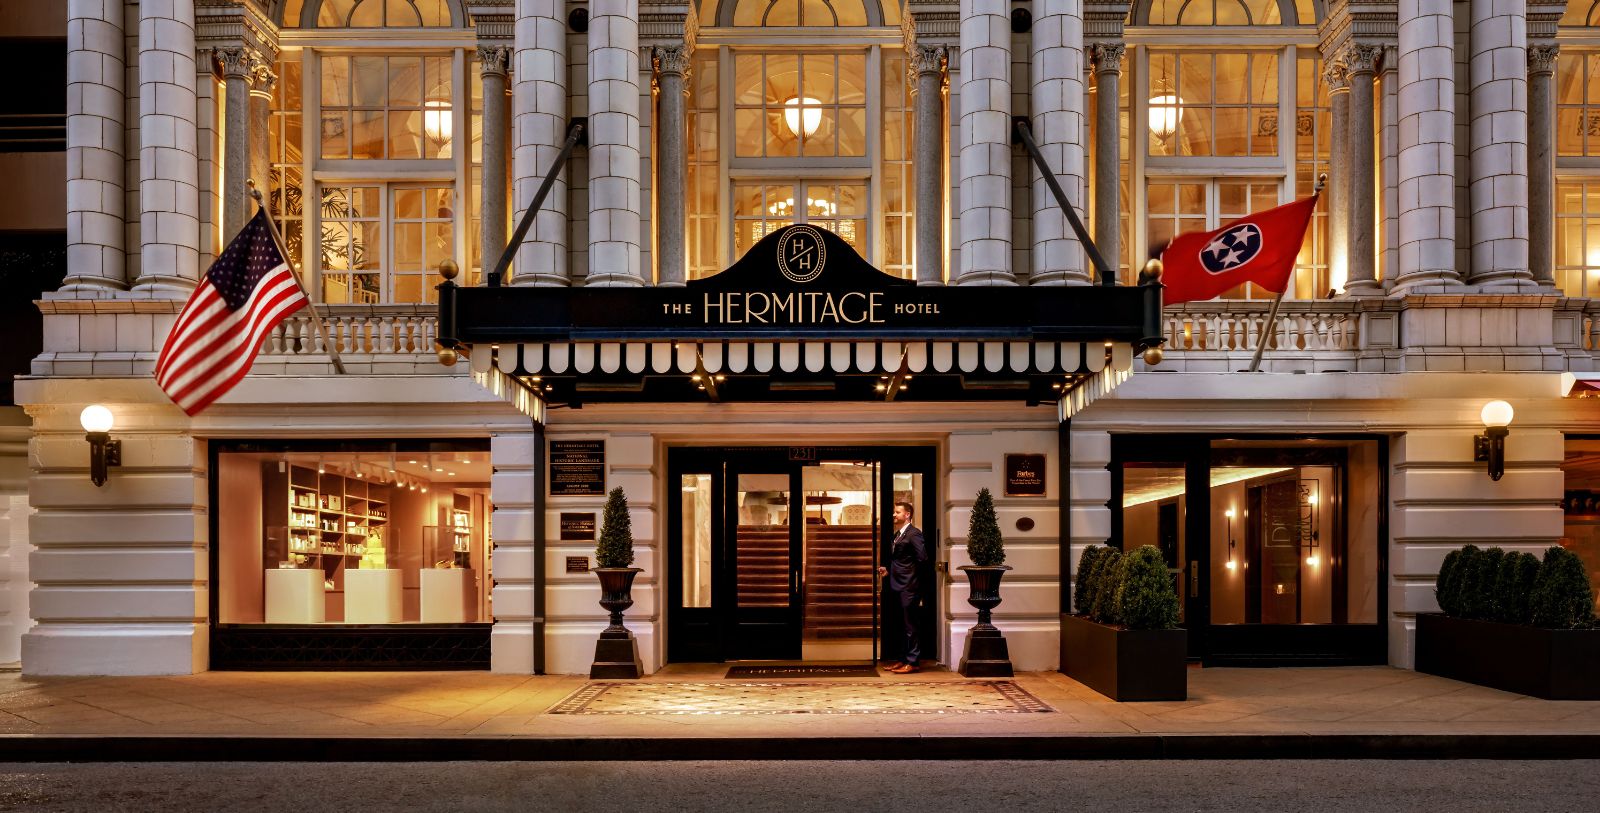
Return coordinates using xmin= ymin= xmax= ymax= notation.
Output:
xmin=1107 ymin=434 xmax=1389 ymax=666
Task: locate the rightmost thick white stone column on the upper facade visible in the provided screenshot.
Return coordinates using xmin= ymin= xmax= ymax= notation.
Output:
xmin=1467 ymin=0 xmax=1533 ymax=286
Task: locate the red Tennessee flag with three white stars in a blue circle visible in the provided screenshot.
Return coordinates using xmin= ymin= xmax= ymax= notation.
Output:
xmin=1162 ymin=195 xmax=1317 ymax=304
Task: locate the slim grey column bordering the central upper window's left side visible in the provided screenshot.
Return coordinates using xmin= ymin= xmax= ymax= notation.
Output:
xmin=656 ymin=45 xmax=690 ymax=288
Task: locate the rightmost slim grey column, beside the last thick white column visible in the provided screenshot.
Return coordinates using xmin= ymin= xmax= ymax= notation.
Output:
xmin=1528 ymin=43 xmax=1560 ymax=286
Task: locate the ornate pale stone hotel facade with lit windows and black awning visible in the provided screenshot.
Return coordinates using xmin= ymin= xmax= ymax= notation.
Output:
xmin=0 ymin=0 xmax=1600 ymax=675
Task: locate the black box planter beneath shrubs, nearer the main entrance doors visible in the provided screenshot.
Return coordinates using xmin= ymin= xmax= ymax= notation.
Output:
xmin=1061 ymin=615 xmax=1189 ymax=701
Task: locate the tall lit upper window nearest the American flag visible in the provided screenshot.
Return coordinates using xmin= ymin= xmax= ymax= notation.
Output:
xmin=272 ymin=0 xmax=483 ymax=304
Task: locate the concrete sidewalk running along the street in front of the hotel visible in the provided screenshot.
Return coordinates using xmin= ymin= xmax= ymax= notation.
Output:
xmin=0 ymin=666 xmax=1600 ymax=760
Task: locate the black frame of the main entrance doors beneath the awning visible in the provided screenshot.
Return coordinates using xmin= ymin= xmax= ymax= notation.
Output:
xmin=664 ymin=445 xmax=941 ymax=663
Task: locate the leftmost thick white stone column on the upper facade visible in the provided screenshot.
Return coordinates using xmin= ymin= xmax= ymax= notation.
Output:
xmin=61 ymin=0 xmax=128 ymax=293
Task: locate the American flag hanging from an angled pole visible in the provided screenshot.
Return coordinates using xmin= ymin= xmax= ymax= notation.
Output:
xmin=155 ymin=211 xmax=307 ymax=415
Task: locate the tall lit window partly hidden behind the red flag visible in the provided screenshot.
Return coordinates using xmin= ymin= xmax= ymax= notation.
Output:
xmin=1122 ymin=0 xmax=1342 ymax=299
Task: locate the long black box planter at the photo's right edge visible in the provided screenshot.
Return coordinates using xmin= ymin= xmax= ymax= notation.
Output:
xmin=1416 ymin=613 xmax=1600 ymax=699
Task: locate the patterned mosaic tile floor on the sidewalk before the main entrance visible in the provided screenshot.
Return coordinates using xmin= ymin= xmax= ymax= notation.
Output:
xmin=549 ymin=680 xmax=1056 ymax=715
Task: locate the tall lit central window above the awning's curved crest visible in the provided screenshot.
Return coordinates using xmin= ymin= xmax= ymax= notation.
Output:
xmin=686 ymin=0 xmax=915 ymax=278
